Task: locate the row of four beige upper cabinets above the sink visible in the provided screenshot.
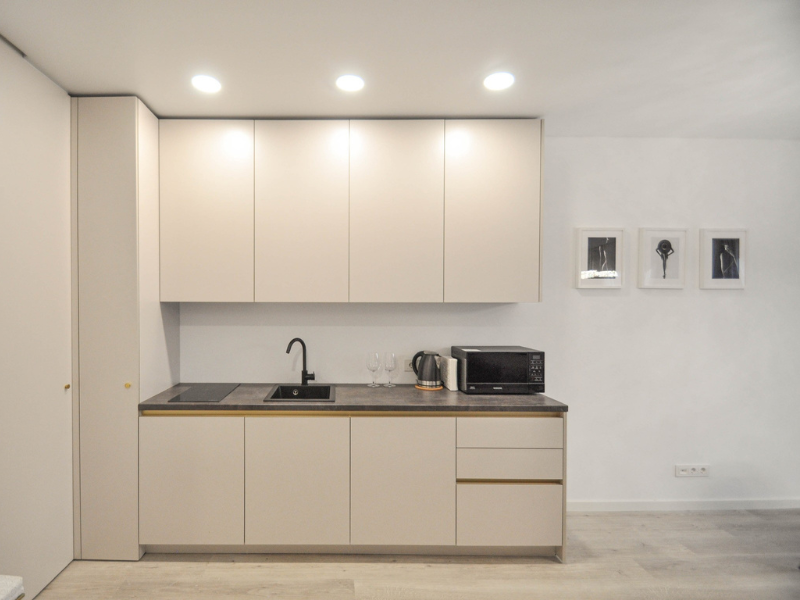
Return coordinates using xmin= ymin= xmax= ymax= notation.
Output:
xmin=155 ymin=119 xmax=542 ymax=302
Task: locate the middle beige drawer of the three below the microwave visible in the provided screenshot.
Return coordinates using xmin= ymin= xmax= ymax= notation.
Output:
xmin=456 ymin=448 xmax=564 ymax=479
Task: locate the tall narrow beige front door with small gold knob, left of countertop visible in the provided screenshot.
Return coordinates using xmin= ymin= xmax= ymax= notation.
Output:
xmin=76 ymin=97 xmax=144 ymax=560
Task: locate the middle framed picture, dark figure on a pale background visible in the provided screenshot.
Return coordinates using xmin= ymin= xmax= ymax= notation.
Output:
xmin=639 ymin=229 xmax=686 ymax=288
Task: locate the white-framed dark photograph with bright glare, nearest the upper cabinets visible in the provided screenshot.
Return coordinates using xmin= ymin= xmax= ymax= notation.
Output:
xmin=577 ymin=229 xmax=623 ymax=288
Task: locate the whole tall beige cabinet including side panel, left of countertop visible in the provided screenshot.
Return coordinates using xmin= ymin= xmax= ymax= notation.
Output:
xmin=73 ymin=96 xmax=178 ymax=560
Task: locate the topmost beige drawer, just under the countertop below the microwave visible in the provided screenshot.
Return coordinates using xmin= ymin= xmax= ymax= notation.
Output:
xmin=456 ymin=417 xmax=564 ymax=448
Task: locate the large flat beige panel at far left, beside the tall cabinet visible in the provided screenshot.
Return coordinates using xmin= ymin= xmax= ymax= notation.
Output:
xmin=0 ymin=43 xmax=72 ymax=598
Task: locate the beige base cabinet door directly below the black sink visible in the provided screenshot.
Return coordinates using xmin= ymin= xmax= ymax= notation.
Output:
xmin=245 ymin=416 xmax=350 ymax=545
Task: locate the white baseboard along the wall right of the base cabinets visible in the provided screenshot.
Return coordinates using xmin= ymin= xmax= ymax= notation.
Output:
xmin=567 ymin=498 xmax=800 ymax=512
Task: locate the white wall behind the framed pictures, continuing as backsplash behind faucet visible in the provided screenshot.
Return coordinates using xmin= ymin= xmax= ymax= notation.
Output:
xmin=181 ymin=138 xmax=800 ymax=508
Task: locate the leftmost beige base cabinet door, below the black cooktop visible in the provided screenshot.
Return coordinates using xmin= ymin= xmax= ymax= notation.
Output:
xmin=139 ymin=417 xmax=244 ymax=545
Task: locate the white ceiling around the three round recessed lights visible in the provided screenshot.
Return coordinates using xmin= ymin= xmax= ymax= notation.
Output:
xmin=0 ymin=0 xmax=800 ymax=139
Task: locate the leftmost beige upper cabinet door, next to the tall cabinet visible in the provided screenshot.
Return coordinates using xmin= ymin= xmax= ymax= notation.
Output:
xmin=159 ymin=119 xmax=254 ymax=302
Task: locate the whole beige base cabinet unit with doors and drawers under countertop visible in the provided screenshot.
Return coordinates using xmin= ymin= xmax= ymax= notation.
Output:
xmin=139 ymin=411 xmax=566 ymax=560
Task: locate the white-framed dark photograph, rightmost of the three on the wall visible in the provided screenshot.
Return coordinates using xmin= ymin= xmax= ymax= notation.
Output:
xmin=700 ymin=229 xmax=747 ymax=290
